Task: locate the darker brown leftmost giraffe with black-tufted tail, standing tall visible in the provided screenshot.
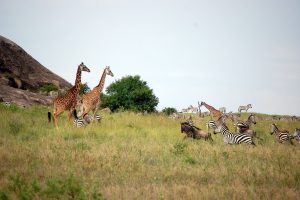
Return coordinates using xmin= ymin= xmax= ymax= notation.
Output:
xmin=48 ymin=62 xmax=90 ymax=127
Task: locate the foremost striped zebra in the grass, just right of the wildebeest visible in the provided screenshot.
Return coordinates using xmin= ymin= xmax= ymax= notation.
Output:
xmin=209 ymin=119 xmax=255 ymax=146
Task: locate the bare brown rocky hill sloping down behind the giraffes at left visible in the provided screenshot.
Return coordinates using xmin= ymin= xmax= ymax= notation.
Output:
xmin=0 ymin=36 xmax=72 ymax=106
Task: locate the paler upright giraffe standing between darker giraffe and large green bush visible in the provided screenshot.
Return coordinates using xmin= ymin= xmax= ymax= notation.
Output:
xmin=79 ymin=66 xmax=114 ymax=119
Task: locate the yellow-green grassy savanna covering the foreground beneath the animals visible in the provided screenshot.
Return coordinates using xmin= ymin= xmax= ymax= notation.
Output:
xmin=0 ymin=105 xmax=300 ymax=199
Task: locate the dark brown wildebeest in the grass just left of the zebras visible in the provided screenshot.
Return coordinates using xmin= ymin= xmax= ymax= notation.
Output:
xmin=181 ymin=122 xmax=213 ymax=141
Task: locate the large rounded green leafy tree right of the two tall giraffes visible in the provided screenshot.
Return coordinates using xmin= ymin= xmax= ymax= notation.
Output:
xmin=101 ymin=76 xmax=159 ymax=112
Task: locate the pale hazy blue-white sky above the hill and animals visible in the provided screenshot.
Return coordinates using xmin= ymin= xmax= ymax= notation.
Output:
xmin=0 ymin=0 xmax=300 ymax=116
